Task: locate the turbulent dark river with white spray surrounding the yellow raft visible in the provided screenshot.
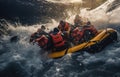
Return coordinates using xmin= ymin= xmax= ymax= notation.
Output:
xmin=0 ymin=0 xmax=120 ymax=77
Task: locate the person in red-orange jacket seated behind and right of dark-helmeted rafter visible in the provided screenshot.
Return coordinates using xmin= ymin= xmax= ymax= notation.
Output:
xmin=58 ymin=20 xmax=71 ymax=39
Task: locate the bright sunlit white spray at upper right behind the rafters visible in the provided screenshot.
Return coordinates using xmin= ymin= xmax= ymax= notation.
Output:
xmin=66 ymin=0 xmax=120 ymax=28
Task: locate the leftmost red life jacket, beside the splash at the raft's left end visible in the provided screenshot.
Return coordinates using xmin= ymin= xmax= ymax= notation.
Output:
xmin=35 ymin=35 xmax=48 ymax=48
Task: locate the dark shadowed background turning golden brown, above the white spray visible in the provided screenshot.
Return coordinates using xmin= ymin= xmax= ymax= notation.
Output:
xmin=0 ymin=0 xmax=105 ymax=25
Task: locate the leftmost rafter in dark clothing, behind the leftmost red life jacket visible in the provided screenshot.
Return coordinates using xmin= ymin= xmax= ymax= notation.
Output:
xmin=30 ymin=25 xmax=48 ymax=42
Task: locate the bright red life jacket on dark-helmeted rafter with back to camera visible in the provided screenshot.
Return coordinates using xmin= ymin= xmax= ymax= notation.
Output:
xmin=50 ymin=32 xmax=65 ymax=47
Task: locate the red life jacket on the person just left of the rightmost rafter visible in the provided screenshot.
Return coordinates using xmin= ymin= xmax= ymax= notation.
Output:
xmin=72 ymin=28 xmax=83 ymax=41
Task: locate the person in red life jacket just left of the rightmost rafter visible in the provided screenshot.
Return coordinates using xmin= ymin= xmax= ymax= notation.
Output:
xmin=71 ymin=27 xmax=83 ymax=45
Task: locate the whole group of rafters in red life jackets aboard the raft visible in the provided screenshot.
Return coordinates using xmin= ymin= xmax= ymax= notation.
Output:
xmin=30 ymin=15 xmax=98 ymax=51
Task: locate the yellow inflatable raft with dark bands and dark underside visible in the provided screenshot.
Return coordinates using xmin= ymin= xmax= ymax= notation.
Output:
xmin=48 ymin=28 xmax=117 ymax=58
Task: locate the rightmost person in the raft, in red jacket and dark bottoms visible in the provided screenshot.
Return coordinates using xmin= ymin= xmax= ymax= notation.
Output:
xmin=82 ymin=21 xmax=98 ymax=41
